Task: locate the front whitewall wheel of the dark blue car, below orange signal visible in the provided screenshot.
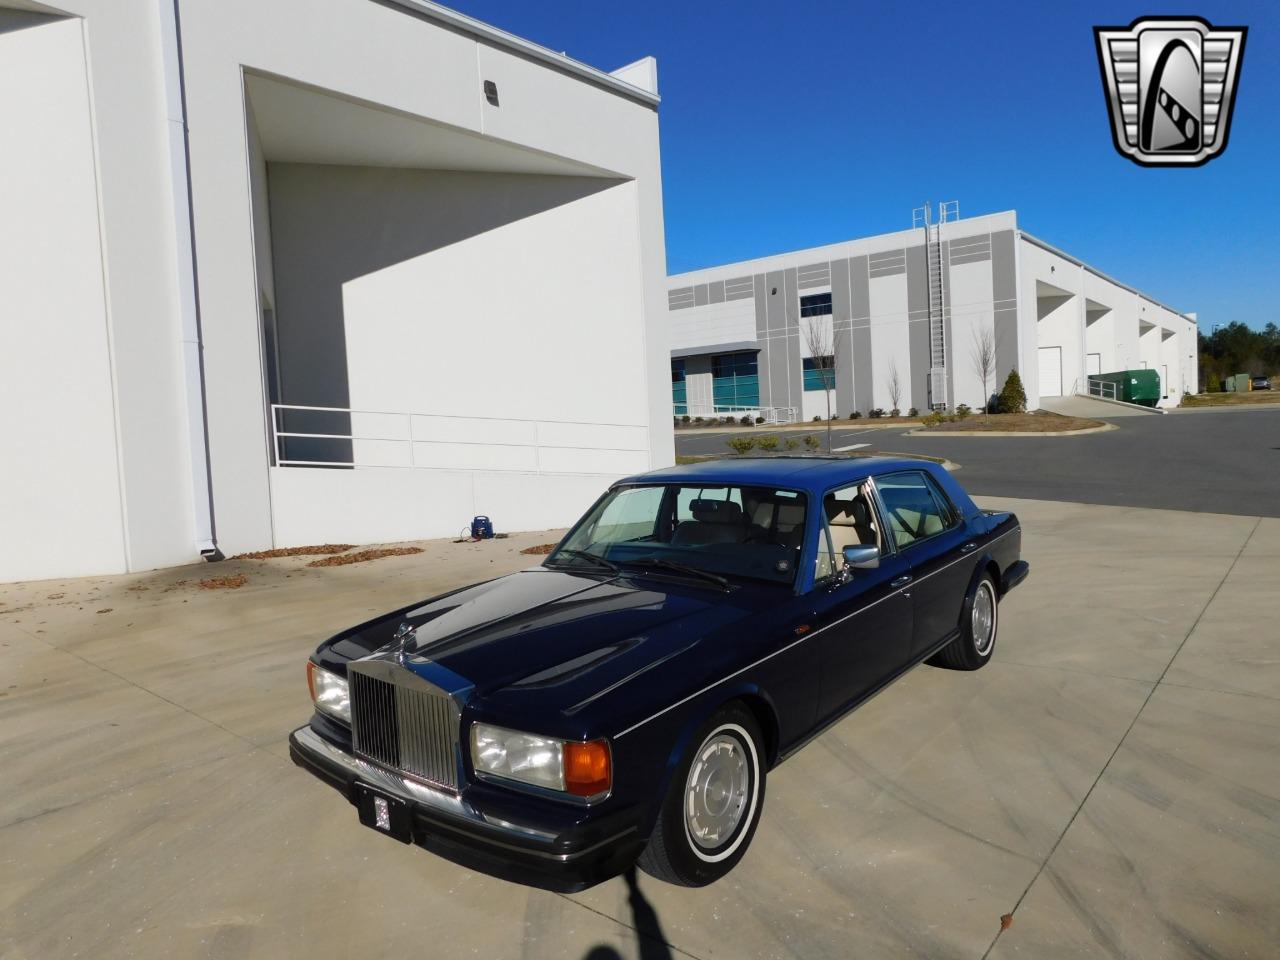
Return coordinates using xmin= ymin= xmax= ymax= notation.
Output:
xmin=639 ymin=703 xmax=764 ymax=887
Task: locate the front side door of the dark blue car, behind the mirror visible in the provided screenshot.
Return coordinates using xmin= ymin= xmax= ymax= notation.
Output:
xmin=810 ymin=485 xmax=911 ymax=721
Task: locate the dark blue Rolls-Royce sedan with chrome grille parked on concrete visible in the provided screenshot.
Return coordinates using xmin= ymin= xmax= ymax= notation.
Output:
xmin=289 ymin=457 xmax=1028 ymax=890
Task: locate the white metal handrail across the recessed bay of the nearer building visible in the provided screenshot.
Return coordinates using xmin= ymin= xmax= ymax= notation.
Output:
xmin=270 ymin=403 xmax=649 ymax=476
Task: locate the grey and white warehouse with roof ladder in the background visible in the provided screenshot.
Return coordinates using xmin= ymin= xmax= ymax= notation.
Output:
xmin=667 ymin=204 xmax=1197 ymax=422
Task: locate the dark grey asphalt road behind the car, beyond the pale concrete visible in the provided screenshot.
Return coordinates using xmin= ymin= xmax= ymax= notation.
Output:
xmin=676 ymin=408 xmax=1280 ymax=517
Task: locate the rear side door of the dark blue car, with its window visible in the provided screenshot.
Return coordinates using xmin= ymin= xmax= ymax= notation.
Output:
xmin=874 ymin=470 xmax=977 ymax=657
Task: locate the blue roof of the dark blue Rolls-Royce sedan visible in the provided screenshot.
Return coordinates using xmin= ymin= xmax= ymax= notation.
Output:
xmin=618 ymin=456 xmax=936 ymax=493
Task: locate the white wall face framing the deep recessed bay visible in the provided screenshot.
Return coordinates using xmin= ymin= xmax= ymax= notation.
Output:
xmin=182 ymin=0 xmax=673 ymax=550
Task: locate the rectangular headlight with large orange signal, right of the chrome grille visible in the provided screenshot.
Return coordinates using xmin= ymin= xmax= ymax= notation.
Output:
xmin=471 ymin=723 xmax=612 ymax=797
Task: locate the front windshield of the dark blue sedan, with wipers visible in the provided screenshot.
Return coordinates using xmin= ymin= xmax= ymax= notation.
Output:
xmin=547 ymin=484 xmax=805 ymax=584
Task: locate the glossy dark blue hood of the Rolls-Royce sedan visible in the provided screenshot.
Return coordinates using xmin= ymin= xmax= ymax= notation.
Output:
xmin=330 ymin=567 xmax=754 ymax=713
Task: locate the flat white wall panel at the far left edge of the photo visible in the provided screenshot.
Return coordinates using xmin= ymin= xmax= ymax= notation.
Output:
xmin=0 ymin=18 xmax=128 ymax=581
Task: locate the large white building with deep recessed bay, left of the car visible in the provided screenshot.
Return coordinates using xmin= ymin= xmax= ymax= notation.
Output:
xmin=0 ymin=0 xmax=673 ymax=581
